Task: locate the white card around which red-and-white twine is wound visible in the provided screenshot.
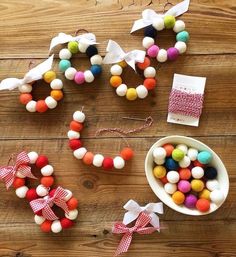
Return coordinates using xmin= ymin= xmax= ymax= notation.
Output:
xmin=167 ymin=74 xmax=206 ymax=127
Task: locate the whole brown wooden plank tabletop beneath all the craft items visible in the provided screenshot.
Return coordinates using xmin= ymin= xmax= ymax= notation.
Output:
xmin=0 ymin=0 xmax=236 ymax=257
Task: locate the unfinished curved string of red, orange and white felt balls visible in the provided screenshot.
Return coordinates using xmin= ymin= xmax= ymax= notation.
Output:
xmin=67 ymin=111 xmax=134 ymax=170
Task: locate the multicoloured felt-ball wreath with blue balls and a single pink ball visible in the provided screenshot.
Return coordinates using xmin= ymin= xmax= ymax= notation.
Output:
xmin=59 ymin=41 xmax=102 ymax=85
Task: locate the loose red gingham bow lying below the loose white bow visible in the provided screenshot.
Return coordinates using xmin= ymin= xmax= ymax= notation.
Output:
xmin=112 ymin=212 xmax=157 ymax=256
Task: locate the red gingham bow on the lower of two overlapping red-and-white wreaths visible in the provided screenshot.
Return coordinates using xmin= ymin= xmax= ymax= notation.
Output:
xmin=30 ymin=187 xmax=69 ymax=220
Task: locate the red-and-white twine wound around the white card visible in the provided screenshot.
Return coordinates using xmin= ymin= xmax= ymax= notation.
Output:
xmin=168 ymin=89 xmax=203 ymax=118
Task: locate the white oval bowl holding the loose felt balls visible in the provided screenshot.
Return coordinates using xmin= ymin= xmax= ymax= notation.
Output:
xmin=145 ymin=136 xmax=229 ymax=216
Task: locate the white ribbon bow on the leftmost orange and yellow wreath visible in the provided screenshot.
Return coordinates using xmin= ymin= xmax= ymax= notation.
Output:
xmin=0 ymin=55 xmax=54 ymax=90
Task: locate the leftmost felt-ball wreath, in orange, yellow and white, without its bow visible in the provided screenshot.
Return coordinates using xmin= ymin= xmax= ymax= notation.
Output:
xmin=19 ymin=71 xmax=63 ymax=113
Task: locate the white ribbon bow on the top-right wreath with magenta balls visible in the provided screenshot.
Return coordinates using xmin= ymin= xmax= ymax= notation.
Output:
xmin=130 ymin=0 xmax=190 ymax=33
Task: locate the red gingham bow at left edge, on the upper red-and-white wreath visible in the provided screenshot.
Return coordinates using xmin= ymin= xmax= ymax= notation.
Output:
xmin=0 ymin=151 xmax=37 ymax=189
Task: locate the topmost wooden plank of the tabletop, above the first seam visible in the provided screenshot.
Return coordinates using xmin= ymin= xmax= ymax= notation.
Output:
xmin=0 ymin=0 xmax=236 ymax=58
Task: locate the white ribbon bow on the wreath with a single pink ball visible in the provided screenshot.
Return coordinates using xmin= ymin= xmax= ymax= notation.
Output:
xmin=49 ymin=33 xmax=97 ymax=52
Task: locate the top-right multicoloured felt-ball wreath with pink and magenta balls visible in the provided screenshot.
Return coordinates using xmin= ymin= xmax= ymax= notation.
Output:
xmin=143 ymin=15 xmax=189 ymax=62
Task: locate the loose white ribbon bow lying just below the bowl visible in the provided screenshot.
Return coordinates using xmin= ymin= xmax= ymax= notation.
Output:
xmin=123 ymin=199 xmax=163 ymax=231
